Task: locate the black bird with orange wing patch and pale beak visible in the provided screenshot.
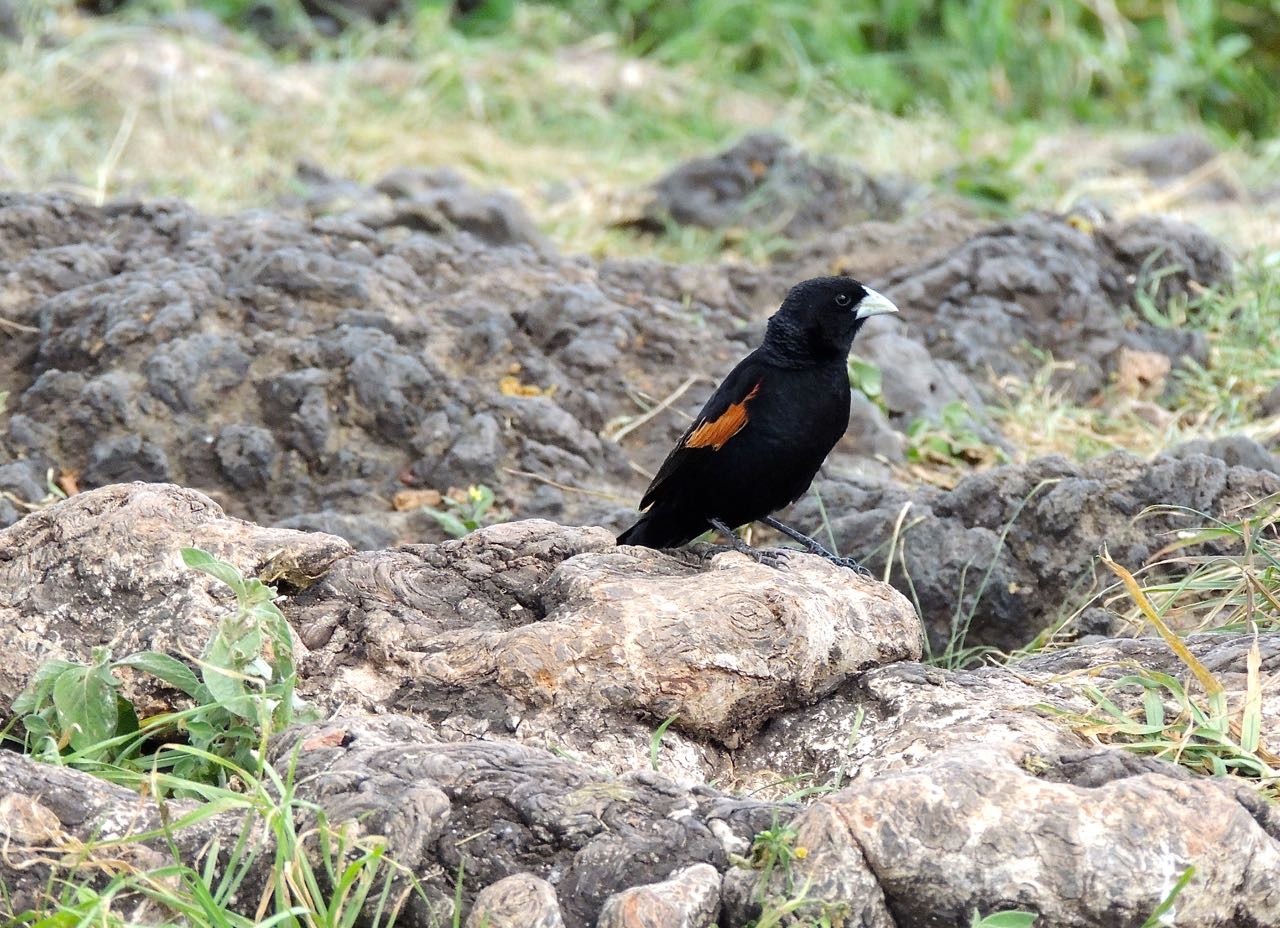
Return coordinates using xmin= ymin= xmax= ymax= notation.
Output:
xmin=618 ymin=276 xmax=897 ymax=570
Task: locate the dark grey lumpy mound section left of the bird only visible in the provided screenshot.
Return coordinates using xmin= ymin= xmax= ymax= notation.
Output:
xmin=0 ymin=196 xmax=768 ymax=547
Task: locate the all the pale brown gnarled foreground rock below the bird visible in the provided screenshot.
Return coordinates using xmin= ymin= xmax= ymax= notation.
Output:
xmin=0 ymin=484 xmax=1280 ymax=928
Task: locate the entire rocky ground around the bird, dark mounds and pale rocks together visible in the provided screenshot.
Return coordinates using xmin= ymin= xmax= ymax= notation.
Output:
xmin=0 ymin=131 xmax=1280 ymax=928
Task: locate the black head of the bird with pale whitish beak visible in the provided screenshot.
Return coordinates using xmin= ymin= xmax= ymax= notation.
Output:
xmin=764 ymin=276 xmax=897 ymax=364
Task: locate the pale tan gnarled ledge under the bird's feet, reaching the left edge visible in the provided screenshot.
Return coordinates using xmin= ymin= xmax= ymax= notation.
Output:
xmin=0 ymin=484 xmax=920 ymax=764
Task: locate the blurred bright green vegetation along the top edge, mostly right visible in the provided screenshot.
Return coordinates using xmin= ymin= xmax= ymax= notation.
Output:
xmin=117 ymin=0 xmax=1280 ymax=137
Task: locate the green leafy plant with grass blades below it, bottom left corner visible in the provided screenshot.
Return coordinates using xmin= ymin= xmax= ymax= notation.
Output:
xmin=9 ymin=549 xmax=437 ymax=928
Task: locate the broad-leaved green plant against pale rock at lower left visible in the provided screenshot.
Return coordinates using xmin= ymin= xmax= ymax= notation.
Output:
xmin=13 ymin=548 xmax=315 ymax=782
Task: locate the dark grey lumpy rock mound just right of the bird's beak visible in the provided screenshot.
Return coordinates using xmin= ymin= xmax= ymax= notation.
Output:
xmin=872 ymin=215 xmax=1231 ymax=397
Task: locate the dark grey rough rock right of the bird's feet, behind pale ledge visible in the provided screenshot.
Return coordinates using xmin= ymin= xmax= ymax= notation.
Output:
xmin=794 ymin=452 xmax=1280 ymax=652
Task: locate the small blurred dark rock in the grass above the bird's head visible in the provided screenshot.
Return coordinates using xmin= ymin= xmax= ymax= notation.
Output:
xmin=630 ymin=133 xmax=914 ymax=239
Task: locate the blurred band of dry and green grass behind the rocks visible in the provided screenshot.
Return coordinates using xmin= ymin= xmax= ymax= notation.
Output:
xmin=0 ymin=0 xmax=1280 ymax=254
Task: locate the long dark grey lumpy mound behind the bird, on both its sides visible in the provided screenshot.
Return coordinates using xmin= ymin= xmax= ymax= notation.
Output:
xmin=0 ymin=184 xmax=1244 ymax=586
